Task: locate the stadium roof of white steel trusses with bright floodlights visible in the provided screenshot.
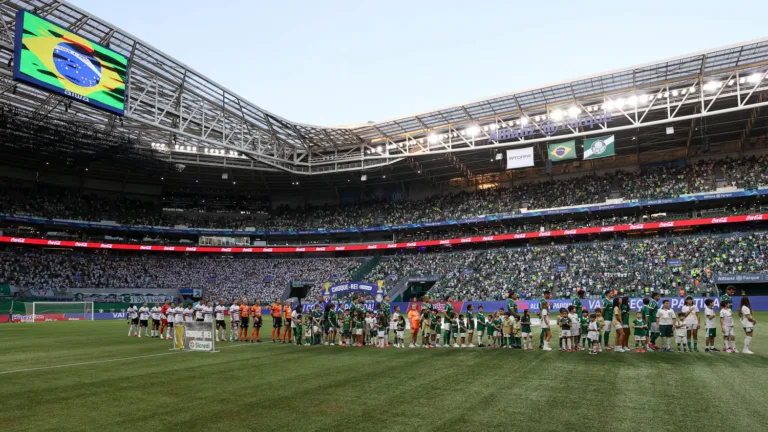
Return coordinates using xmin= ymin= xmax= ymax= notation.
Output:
xmin=0 ymin=0 xmax=768 ymax=186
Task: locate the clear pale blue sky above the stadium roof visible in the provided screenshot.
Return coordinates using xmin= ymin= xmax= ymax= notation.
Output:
xmin=73 ymin=0 xmax=768 ymax=126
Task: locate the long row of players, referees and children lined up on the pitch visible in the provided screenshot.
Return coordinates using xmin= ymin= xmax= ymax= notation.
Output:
xmin=128 ymin=286 xmax=757 ymax=354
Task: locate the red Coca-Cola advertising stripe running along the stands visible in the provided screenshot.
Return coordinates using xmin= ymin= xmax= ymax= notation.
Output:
xmin=0 ymin=213 xmax=768 ymax=253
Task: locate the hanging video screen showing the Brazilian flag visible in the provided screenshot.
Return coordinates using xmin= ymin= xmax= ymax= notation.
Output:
xmin=13 ymin=11 xmax=128 ymax=115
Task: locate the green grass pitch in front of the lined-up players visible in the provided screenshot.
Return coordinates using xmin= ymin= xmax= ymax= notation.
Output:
xmin=0 ymin=313 xmax=768 ymax=432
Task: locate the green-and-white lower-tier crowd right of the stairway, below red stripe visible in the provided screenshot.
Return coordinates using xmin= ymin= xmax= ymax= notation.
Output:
xmin=368 ymin=232 xmax=768 ymax=300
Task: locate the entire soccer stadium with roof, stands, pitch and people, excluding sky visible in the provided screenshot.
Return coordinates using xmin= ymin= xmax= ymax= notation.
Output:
xmin=0 ymin=0 xmax=768 ymax=431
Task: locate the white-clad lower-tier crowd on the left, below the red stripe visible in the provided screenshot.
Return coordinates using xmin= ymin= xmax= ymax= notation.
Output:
xmin=0 ymin=250 xmax=365 ymax=301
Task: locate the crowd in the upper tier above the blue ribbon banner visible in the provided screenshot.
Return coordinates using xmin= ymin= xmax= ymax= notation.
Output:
xmin=0 ymin=157 xmax=768 ymax=231
